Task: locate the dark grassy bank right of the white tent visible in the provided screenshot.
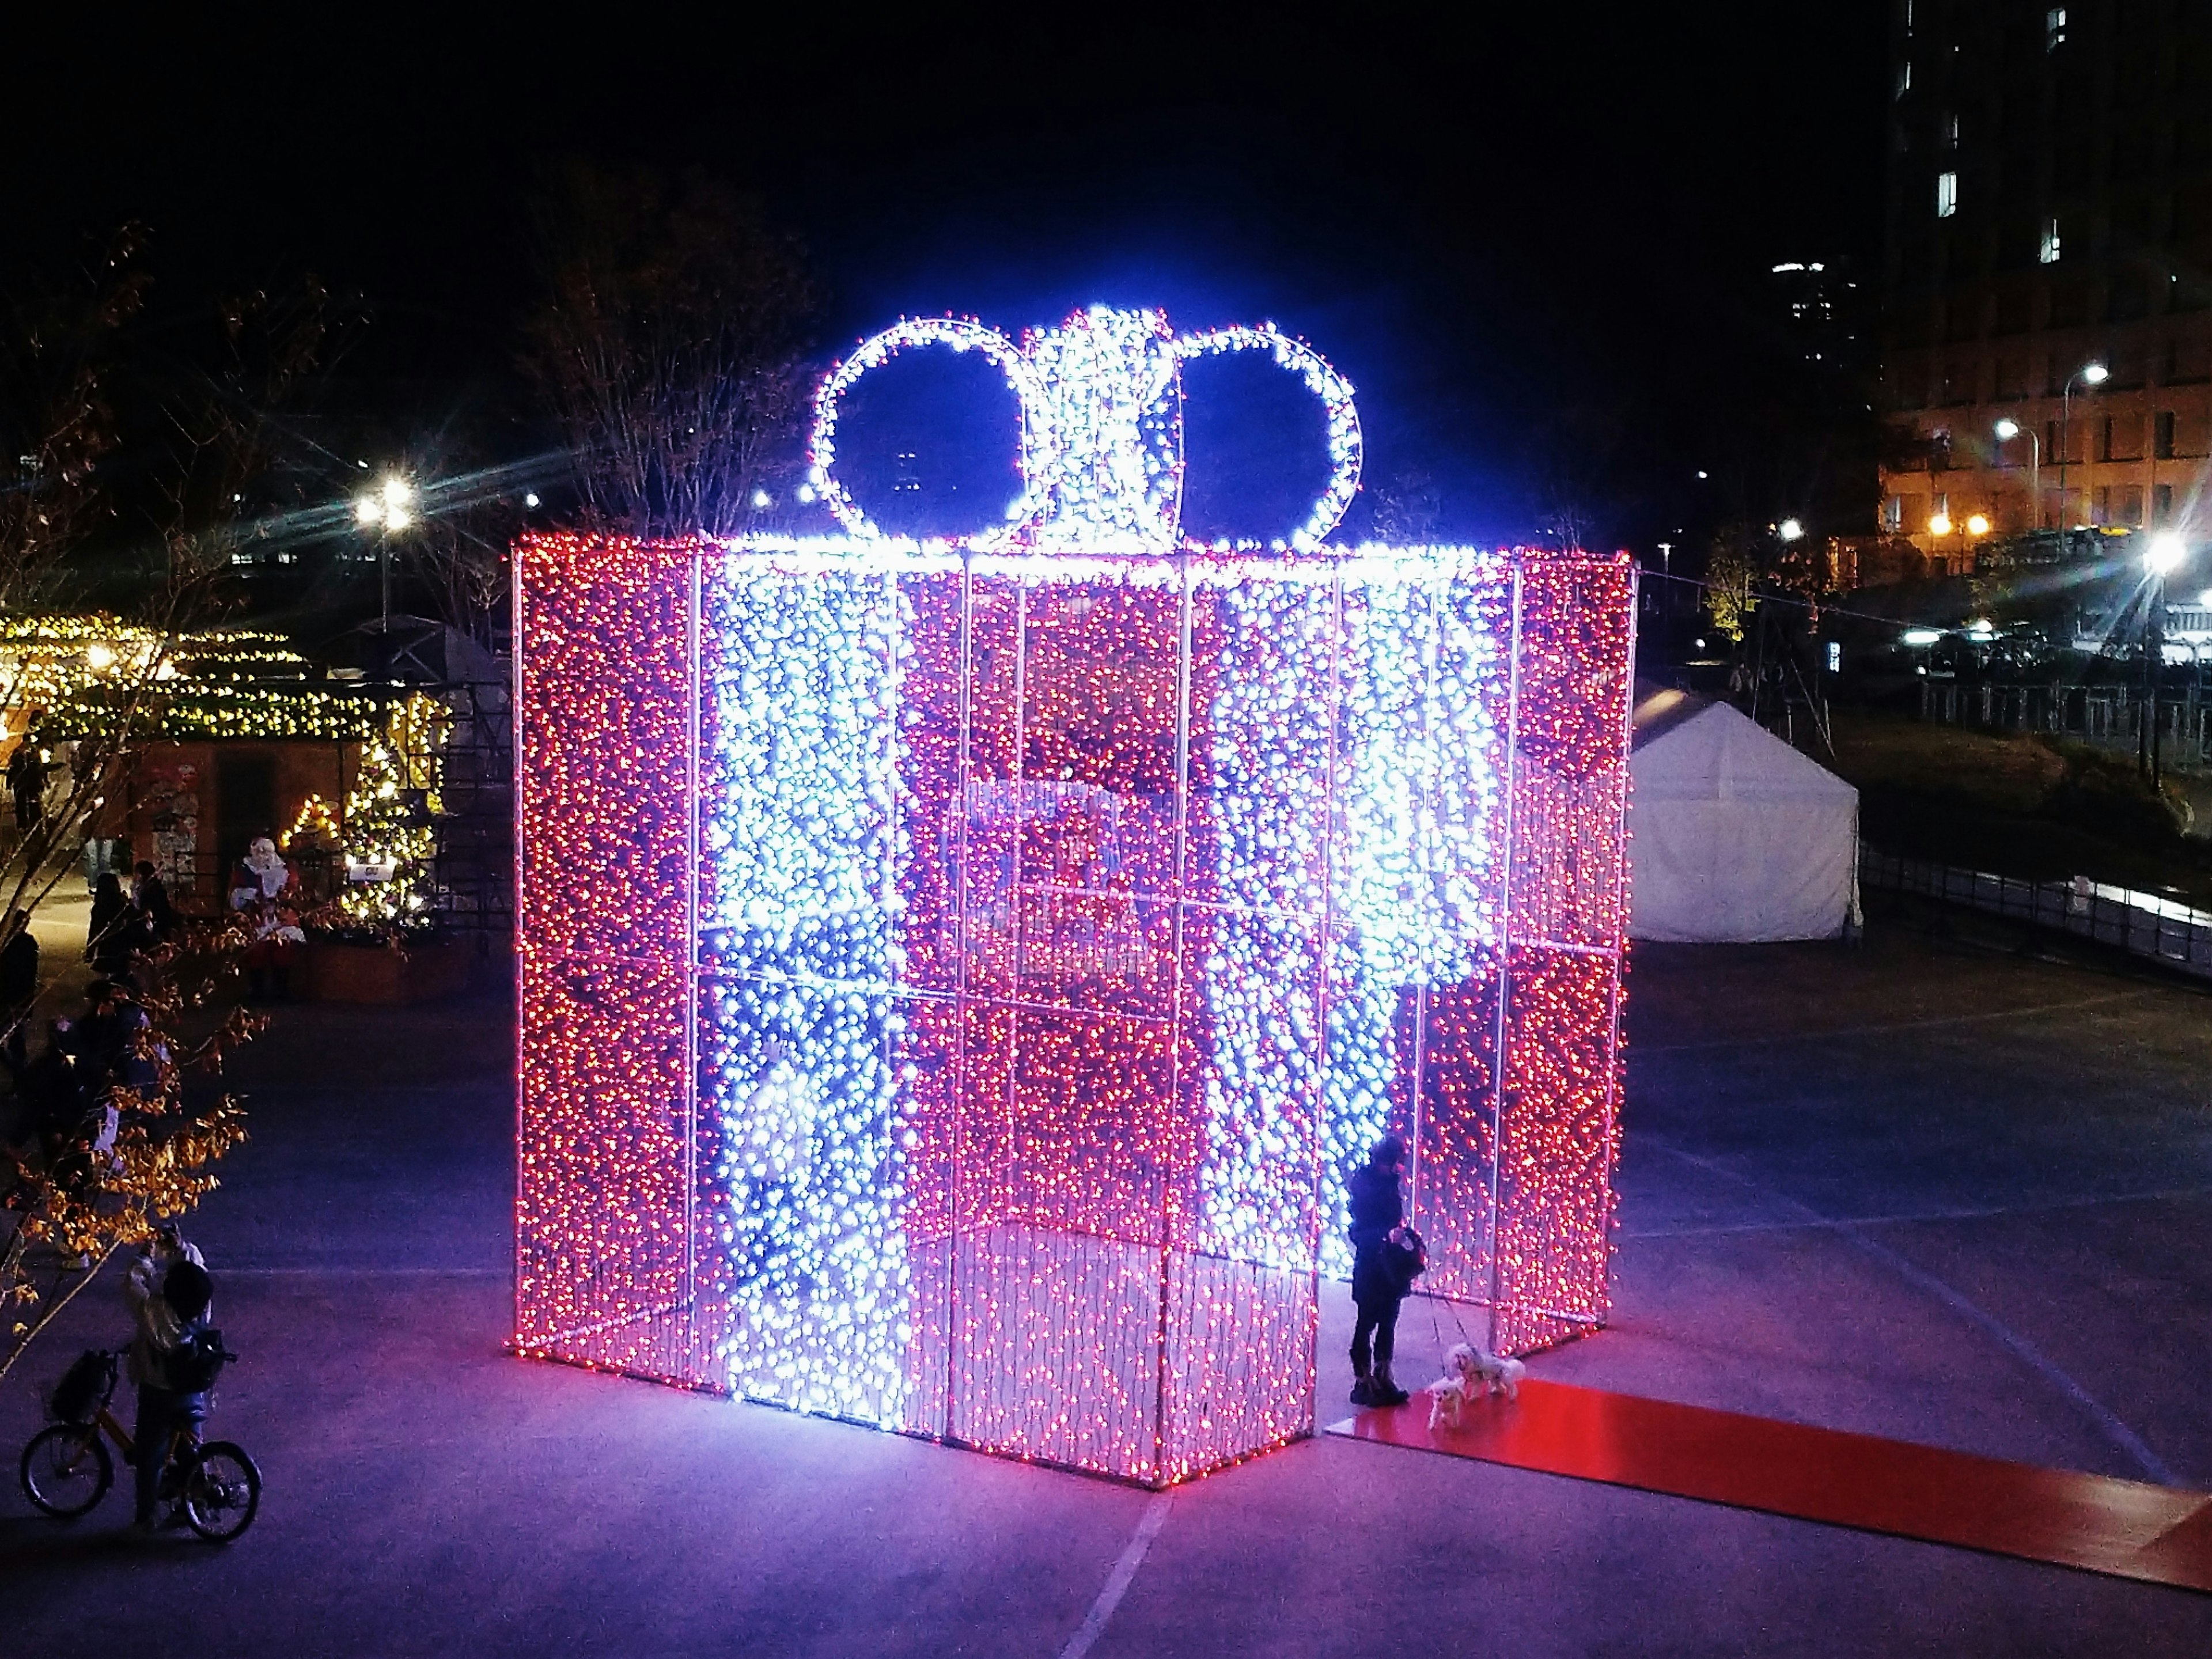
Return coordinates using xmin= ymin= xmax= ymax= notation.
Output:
xmin=1836 ymin=712 xmax=2212 ymax=903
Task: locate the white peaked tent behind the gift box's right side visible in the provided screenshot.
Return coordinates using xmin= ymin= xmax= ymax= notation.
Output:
xmin=1628 ymin=690 xmax=1858 ymax=940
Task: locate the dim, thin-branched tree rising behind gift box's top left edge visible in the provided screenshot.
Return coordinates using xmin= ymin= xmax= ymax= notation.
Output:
xmin=522 ymin=161 xmax=814 ymax=535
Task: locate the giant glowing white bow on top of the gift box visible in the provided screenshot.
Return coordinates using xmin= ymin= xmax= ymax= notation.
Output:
xmin=808 ymin=305 xmax=1361 ymax=553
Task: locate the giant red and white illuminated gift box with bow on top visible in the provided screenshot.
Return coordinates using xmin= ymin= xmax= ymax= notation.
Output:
xmin=516 ymin=312 xmax=1633 ymax=1484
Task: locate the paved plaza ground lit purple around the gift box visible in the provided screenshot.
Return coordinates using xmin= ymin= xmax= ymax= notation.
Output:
xmin=0 ymin=911 xmax=2212 ymax=1659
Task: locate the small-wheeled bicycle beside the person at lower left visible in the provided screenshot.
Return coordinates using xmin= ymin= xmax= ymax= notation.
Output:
xmin=18 ymin=1347 xmax=261 ymax=1544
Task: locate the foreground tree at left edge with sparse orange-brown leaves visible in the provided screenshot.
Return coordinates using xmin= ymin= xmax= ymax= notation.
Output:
xmin=0 ymin=228 xmax=349 ymax=1376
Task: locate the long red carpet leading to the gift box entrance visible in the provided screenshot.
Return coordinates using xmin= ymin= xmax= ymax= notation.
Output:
xmin=1327 ymin=1380 xmax=2212 ymax=1593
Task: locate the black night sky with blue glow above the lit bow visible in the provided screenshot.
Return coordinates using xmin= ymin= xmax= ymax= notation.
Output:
xmin=13 ymin=0 xmax=1885 ymax=548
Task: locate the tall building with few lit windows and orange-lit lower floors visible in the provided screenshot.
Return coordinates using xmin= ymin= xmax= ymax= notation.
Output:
xmin=1878 ymin=0 xmax=2212 ymax=571
